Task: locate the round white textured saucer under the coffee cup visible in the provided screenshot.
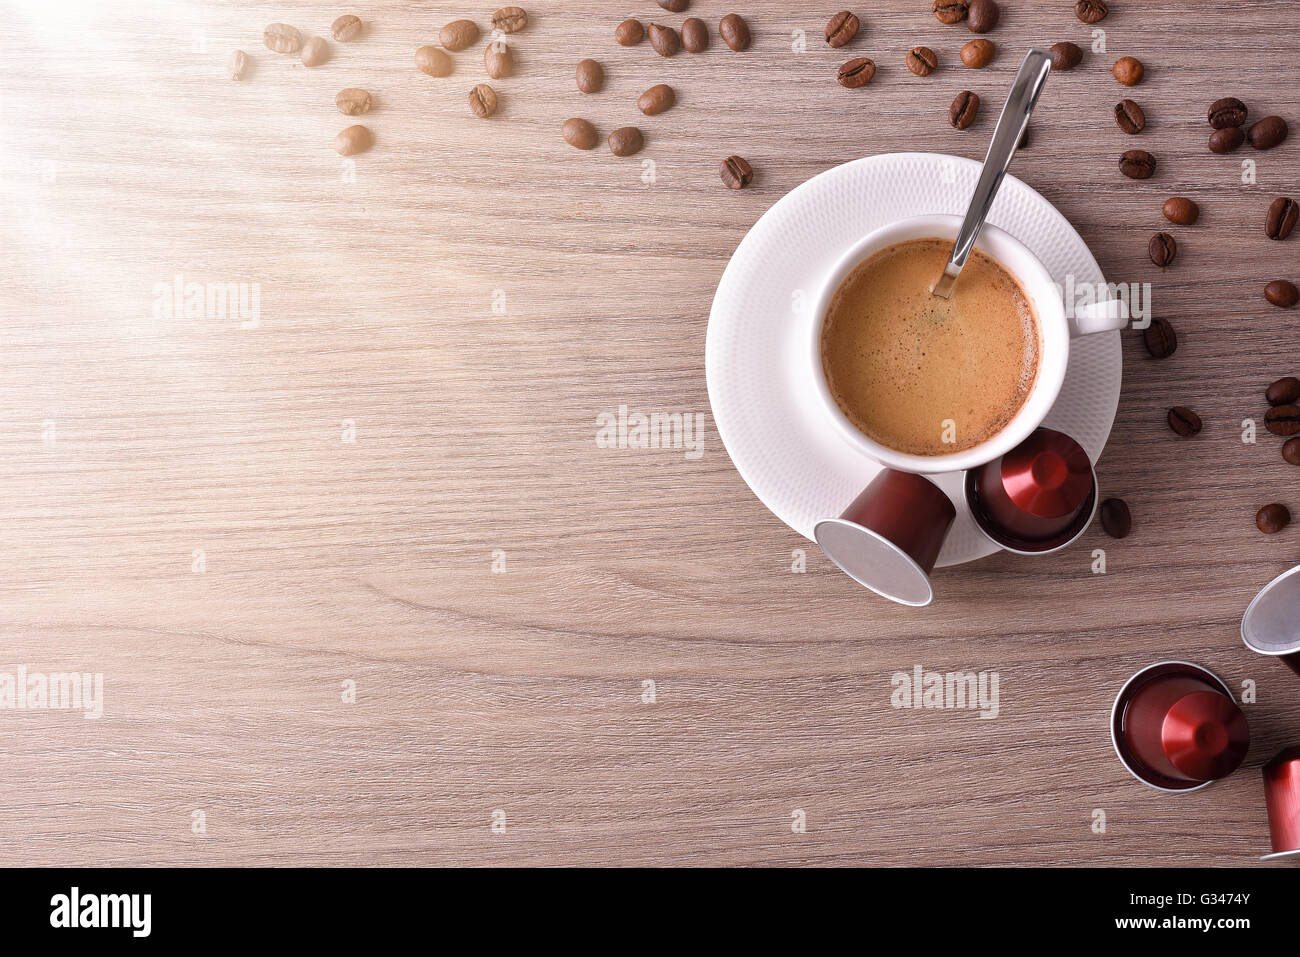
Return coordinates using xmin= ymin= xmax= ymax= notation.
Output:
xmin=705 ymin=153 xmax=1123 ymax=566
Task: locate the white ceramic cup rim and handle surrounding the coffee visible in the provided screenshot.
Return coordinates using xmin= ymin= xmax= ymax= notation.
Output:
xmin=809 ymin=215 xmax=1128 ymax=475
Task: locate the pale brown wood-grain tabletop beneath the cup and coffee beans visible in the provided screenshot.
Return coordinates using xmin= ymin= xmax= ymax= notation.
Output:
xmin=0 ymin=0 xmax=1300 ymax=865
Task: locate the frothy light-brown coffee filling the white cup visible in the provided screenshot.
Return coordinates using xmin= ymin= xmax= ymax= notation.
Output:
xmin=822 ymin=239 xmax=1041 ymax=455
